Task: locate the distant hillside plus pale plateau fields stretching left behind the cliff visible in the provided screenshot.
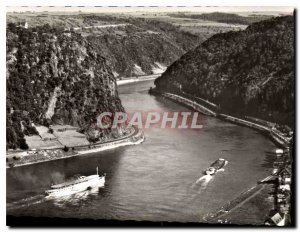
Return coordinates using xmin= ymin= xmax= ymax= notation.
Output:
xmin=7 ymin=12 xmax=244 ymax=78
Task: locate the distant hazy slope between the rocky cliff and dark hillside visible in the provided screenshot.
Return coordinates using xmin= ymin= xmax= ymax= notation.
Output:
xmin=88 ymin=25 xmax=185 ymax=77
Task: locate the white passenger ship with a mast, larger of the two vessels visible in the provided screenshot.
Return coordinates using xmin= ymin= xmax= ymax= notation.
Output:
xmin=46 ymin=167 xmax=105 ymax=197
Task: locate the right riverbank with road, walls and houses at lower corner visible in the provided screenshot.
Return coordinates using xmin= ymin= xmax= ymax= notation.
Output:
xmin=149 ymin=89 xmax=292 ymax=225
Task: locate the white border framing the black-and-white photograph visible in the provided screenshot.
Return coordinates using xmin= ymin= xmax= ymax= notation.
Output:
xmin=0 ymin=0 xmax=300 ymax=231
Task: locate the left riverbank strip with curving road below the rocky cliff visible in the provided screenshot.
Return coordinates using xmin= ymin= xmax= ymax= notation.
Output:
xmin=6 ymin=127 xmax=145 ymax=168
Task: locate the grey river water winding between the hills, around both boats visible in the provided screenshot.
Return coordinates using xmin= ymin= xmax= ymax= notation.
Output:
xmin=7 ymin=80 xmax=275 ymax=222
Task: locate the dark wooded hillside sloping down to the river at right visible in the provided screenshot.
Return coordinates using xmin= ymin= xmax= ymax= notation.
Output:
xmin=155 ymin=16 xmax=295 ymax=127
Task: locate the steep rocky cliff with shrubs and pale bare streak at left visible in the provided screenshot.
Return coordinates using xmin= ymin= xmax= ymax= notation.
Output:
xmin=6 ymin=24 xmax=123 ymax=148
